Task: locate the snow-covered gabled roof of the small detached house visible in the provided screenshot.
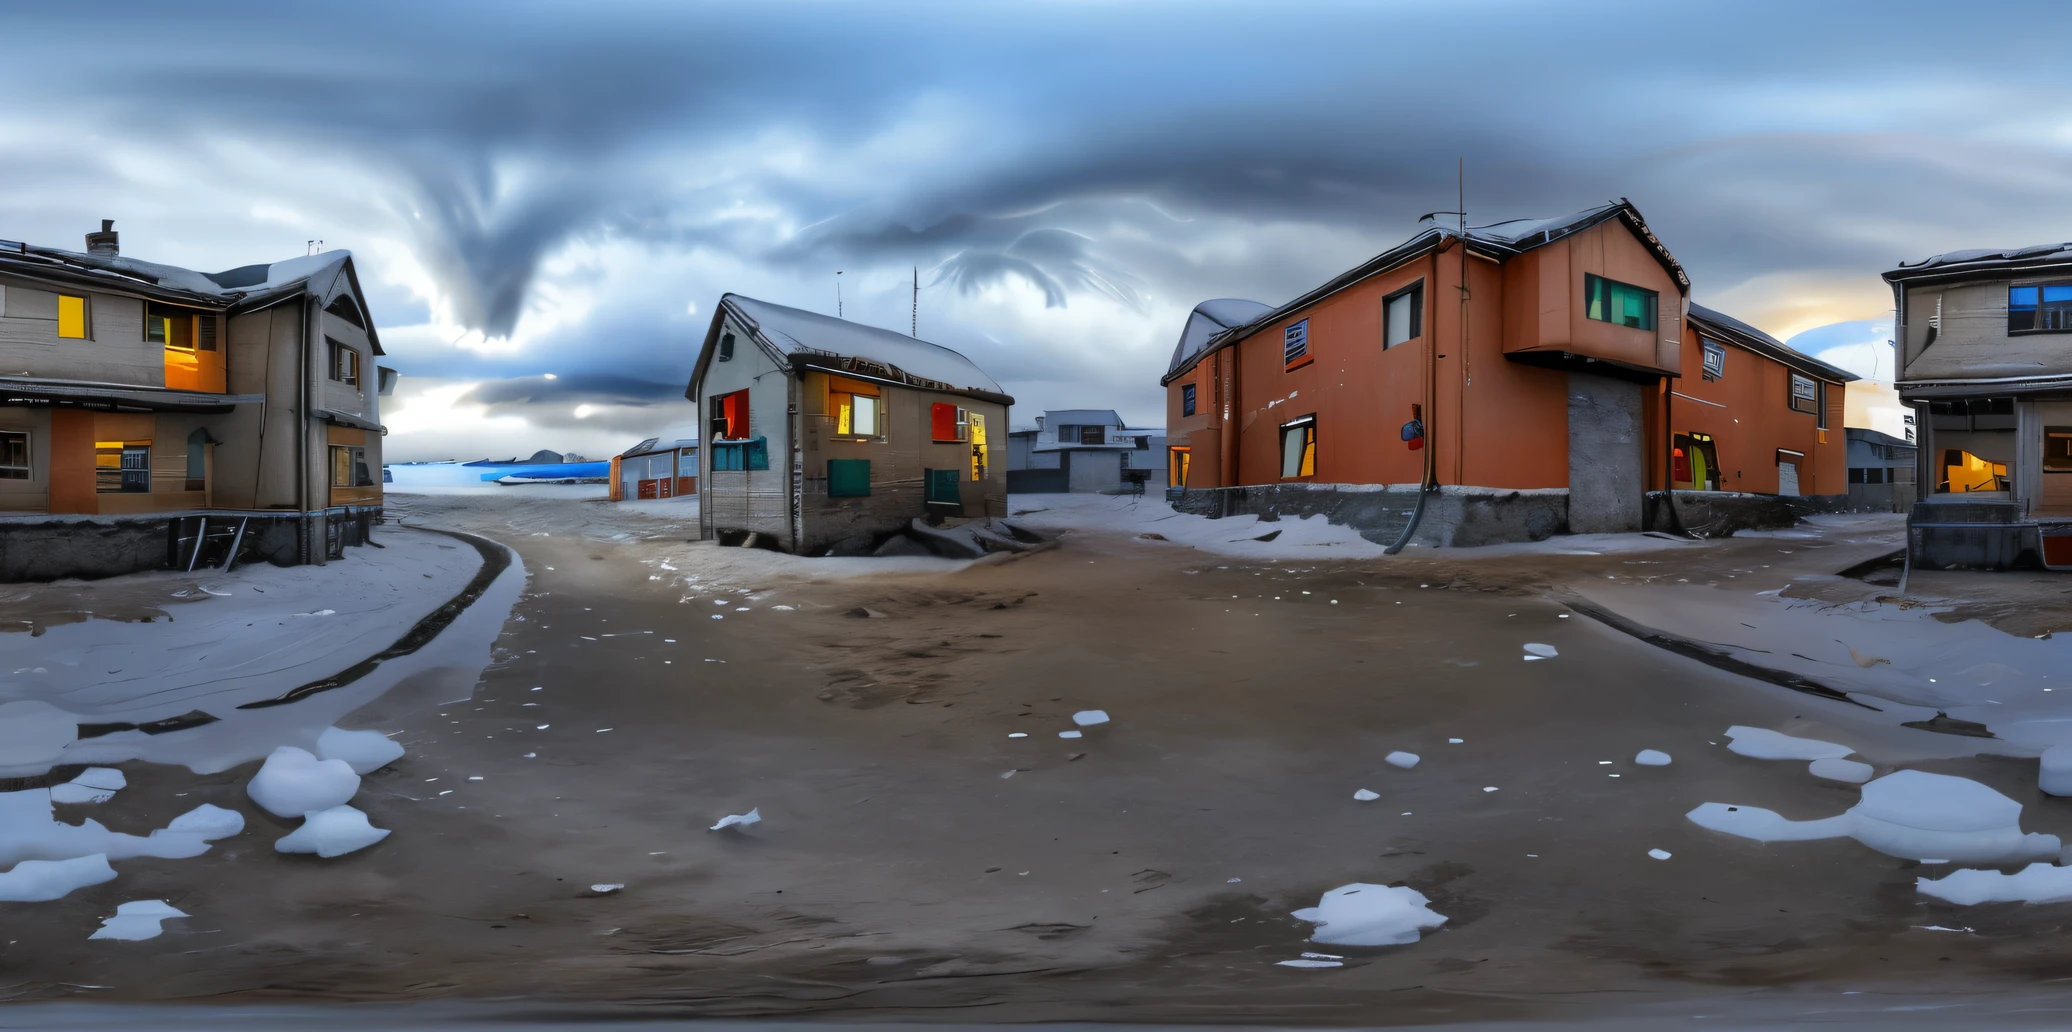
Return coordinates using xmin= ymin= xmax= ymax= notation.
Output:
xmin=694 ymin=294 xmax=1013 ymax=404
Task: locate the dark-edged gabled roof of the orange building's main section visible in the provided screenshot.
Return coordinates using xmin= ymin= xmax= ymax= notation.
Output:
xmin=1160 ymin=199 xmax=1691 ymax=383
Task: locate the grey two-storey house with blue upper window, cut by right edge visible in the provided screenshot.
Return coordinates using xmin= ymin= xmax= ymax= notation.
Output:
xmin=1886 ymin=242 xmax=2072 ymax=570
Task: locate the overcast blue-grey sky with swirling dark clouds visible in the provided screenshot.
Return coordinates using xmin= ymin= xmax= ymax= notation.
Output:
xmin=0 ymin=0 xmax=2072 ymax=460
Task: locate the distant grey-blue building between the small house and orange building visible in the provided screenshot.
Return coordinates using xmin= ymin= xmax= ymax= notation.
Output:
xmin=1007 ymin=408 xmax=1167 ymax=495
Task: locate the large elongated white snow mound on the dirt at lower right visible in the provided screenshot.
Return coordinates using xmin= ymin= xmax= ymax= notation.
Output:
xmin=1685 ymin=771 xmax=2060 ymax=864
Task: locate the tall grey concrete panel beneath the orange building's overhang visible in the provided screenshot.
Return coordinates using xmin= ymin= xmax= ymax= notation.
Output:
xmin=1569 ymin=373 xmax=1647 ymax=535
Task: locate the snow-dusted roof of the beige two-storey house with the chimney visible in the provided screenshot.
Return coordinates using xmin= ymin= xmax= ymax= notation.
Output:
xmin=0 ymin=240 xmax=387 ymax=354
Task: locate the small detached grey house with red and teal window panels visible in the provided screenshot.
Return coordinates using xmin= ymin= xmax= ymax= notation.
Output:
xmin=686 ymin=294 xmax=1013 ymax=555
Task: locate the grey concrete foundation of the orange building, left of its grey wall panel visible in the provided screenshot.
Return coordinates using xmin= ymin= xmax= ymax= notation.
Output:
xmin=1173 ymin=483 xmax=1569 ymax=547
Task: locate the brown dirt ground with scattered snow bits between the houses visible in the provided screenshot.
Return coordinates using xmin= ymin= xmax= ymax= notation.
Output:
xmin=12 ymin=497 xmax=2072 ymax=1024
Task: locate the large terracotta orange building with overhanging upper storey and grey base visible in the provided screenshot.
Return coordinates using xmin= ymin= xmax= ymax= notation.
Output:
xmin=1162 ymin=201 xmax=1848 ymax=545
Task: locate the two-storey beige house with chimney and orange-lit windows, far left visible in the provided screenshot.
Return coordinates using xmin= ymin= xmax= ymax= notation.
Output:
xmin=0 ymin=222 xmax=396 ymax=580
